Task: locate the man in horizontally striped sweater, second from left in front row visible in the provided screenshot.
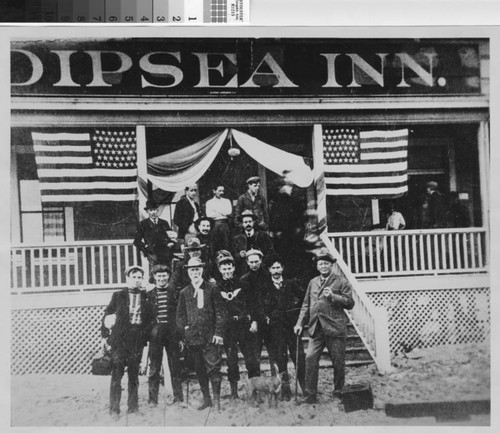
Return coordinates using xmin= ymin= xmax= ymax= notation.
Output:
xmin=147 ymin=265 xmax=183 ymax=406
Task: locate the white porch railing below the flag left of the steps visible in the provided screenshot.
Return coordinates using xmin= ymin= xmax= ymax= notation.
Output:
xmin=10 ymin=240 xmax=141 ymax=293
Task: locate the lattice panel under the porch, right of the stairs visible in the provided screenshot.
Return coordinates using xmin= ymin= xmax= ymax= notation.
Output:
xmin=367 ymin=287 xmax=490 ymax=355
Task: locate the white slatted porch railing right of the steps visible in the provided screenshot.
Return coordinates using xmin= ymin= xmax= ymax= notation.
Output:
xmin=328 ymin=228 xmax=488 ymax=278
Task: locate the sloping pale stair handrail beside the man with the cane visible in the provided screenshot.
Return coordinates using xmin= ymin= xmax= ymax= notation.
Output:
xmin=320 ymin=233 xmax=392 ymax=374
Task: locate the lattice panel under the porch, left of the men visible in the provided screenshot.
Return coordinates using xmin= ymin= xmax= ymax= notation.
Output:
xmin=11 ymin=306 xmax=104 ymax=374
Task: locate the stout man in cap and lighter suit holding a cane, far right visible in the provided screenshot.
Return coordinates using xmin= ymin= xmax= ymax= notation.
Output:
xmin=294 ymin=248 xmax=354 ymax=404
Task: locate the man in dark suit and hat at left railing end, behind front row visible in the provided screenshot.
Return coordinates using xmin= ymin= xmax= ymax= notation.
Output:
xmin=134 ymin=200 xmax=174 ymax=267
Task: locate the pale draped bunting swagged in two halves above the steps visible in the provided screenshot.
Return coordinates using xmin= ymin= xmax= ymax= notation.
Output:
xmin=148 ymin=129 xmax=313 ymax=191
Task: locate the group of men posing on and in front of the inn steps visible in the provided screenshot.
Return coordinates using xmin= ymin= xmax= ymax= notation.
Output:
xmin=102 ymin=177 xmax=354 ymax=417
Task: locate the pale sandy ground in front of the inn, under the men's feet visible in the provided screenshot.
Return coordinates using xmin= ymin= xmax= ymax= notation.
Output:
xmin=11 ymin=345 xmax=490 ymax=427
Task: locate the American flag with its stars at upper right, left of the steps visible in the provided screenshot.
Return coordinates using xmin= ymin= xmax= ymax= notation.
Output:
xmin=32 ymin=129 xmax=137 ymax=205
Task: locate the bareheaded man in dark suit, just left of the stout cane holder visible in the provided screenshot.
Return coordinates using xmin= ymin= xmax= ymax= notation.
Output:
xmin=263 ymin=254 xmax=305 ymax=401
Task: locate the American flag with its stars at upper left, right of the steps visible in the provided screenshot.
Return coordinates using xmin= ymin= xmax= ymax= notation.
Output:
xmin=323 ymin=128 xmax=408 ymax=197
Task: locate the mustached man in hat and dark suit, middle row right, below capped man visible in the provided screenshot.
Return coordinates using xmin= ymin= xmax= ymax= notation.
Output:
xmin=233 ymin=210 xmax=274 ymax=275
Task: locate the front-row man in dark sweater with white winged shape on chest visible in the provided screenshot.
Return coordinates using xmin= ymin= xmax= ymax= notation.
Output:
xmin=217 ymin=250 xmax=260 ymax=399
